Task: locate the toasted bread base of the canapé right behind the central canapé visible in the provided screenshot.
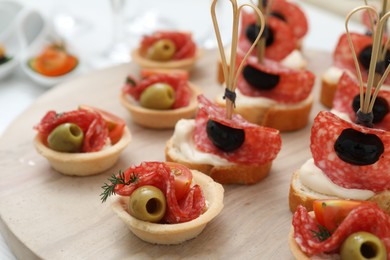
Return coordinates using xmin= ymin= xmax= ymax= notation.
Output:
xmin=217 ymin=94 xmax=314 ymax=132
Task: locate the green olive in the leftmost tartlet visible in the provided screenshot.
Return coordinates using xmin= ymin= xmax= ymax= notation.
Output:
xmin=47 ymin=123 xmax=84 ymax=153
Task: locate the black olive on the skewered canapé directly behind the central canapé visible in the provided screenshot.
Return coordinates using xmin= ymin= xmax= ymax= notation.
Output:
xmin=242 ymin=64 xmax=280 ymax=90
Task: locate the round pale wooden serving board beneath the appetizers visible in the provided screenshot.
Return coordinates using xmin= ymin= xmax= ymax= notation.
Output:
xmin=0 ymin=51 xmax=331 ymax=259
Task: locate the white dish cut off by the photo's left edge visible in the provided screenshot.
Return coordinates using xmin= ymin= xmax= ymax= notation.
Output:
xmin=0 ymin=1 xmax=23 ymax=80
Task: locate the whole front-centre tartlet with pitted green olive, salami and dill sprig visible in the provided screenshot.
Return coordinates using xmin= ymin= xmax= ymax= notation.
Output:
xmin=101 ymin=162 xmax=224 ymax=245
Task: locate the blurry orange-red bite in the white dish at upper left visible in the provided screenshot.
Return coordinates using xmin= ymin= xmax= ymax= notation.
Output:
xmin=28 ymin=42 xmax=78 ymax=77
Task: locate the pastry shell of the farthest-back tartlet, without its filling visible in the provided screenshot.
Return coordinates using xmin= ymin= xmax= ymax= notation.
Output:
xmin=131 ymin=48 xmax=203 ymax=71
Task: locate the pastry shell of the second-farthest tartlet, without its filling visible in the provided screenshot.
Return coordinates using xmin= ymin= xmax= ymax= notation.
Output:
xmin=120 ymin=82 xmax=201 ymax=129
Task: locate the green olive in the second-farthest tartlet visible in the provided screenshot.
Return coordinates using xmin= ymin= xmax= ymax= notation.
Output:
xmin=140 ymin=83 xmax=175 ymax=110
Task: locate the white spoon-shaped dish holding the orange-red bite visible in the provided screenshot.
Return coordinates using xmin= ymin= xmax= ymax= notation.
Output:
xmin=18 ymin=11 xmax=80 ymax=88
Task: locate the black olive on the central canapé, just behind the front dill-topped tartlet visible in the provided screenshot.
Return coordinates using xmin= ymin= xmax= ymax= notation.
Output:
xmin=206 ymin=120 xmax=245 ymax=152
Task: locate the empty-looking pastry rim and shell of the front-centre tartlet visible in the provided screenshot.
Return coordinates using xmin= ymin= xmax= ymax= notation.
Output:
xmin=112 ymin=170 xmax=224 ymax=245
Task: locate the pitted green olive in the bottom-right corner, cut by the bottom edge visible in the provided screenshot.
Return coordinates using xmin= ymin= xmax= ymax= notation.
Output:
xmin=340 ymin=231 xmax=387 ymax=260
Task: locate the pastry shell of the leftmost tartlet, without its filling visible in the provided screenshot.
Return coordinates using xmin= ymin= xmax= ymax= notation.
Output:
xmin=34 ymin=127 xmax=131 ymax=176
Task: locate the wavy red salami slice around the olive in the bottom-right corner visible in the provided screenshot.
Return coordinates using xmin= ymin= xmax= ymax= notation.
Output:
xmin=292 ymin=204 xmax=390 ymax=258
